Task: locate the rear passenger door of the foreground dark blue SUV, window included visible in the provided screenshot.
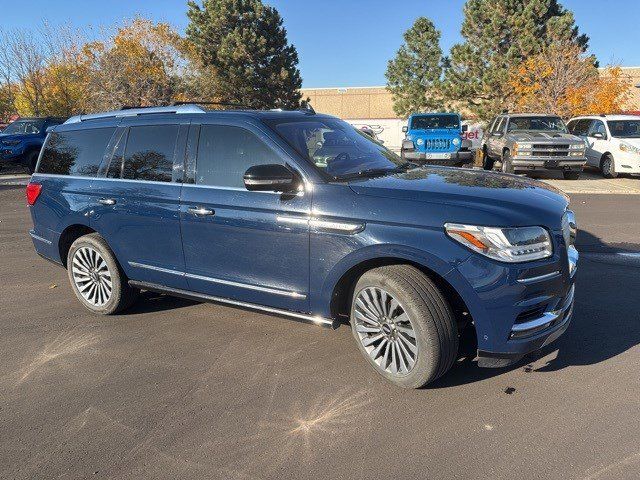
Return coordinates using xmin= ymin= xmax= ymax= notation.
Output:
xmin=91 ymin=116 xmax=189 ymax=288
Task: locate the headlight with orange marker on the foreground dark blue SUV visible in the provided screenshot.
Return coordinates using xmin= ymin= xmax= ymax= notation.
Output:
xmin=444 ymin=223 xmax=553 ymax=263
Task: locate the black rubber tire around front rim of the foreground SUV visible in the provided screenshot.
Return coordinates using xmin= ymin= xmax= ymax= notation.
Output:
xmin=351 ymin=265 xmax=458 ymax=388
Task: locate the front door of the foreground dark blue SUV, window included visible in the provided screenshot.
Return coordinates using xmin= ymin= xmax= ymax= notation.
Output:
xmin=180 ymin=123 xmax=311 ymax=312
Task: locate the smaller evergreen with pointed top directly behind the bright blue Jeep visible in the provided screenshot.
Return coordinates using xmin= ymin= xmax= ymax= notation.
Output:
xmin=385 ymin=17 xmax=442 ymax=117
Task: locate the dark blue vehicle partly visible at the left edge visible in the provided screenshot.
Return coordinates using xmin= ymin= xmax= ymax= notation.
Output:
xmin=0 ymin=117 xmax=64 ymax=173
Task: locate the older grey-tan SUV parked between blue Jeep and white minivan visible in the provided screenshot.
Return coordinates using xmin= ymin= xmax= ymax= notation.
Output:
xmin=482 ymin=113 xmax=587 ymax=180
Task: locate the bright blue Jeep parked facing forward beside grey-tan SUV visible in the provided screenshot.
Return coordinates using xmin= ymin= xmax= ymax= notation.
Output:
xmin=401 ymin=113 xmax=473 ymax=167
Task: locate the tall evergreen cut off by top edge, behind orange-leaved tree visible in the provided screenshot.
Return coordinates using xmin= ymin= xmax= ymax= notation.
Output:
xmin=444 ymin=0 xmax=588 ymax=120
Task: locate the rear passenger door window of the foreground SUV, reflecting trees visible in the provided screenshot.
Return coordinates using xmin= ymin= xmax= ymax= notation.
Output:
xmin=122 ymin=125 xmax=178 ymax=182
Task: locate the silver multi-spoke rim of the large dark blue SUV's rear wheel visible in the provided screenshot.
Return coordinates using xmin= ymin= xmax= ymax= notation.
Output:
xmin=71 ymin=247 xmax=113 ymax=307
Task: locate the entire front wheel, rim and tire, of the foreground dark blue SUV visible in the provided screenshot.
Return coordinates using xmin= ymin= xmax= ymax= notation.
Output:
xmin=351 ymin=265 xmax=458 ymax=388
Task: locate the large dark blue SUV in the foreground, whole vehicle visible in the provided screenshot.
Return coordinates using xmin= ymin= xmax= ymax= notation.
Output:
xmin=27 ymin=105 xmax=578 ymax=388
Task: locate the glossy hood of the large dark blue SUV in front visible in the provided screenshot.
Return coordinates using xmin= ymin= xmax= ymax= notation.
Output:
xmin=349 ymin=167 xmax=569 ymax=229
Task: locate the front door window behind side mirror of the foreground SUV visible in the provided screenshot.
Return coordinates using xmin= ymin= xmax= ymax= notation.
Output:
xmin=196 ymin=125 xmax=283 ymax=188
